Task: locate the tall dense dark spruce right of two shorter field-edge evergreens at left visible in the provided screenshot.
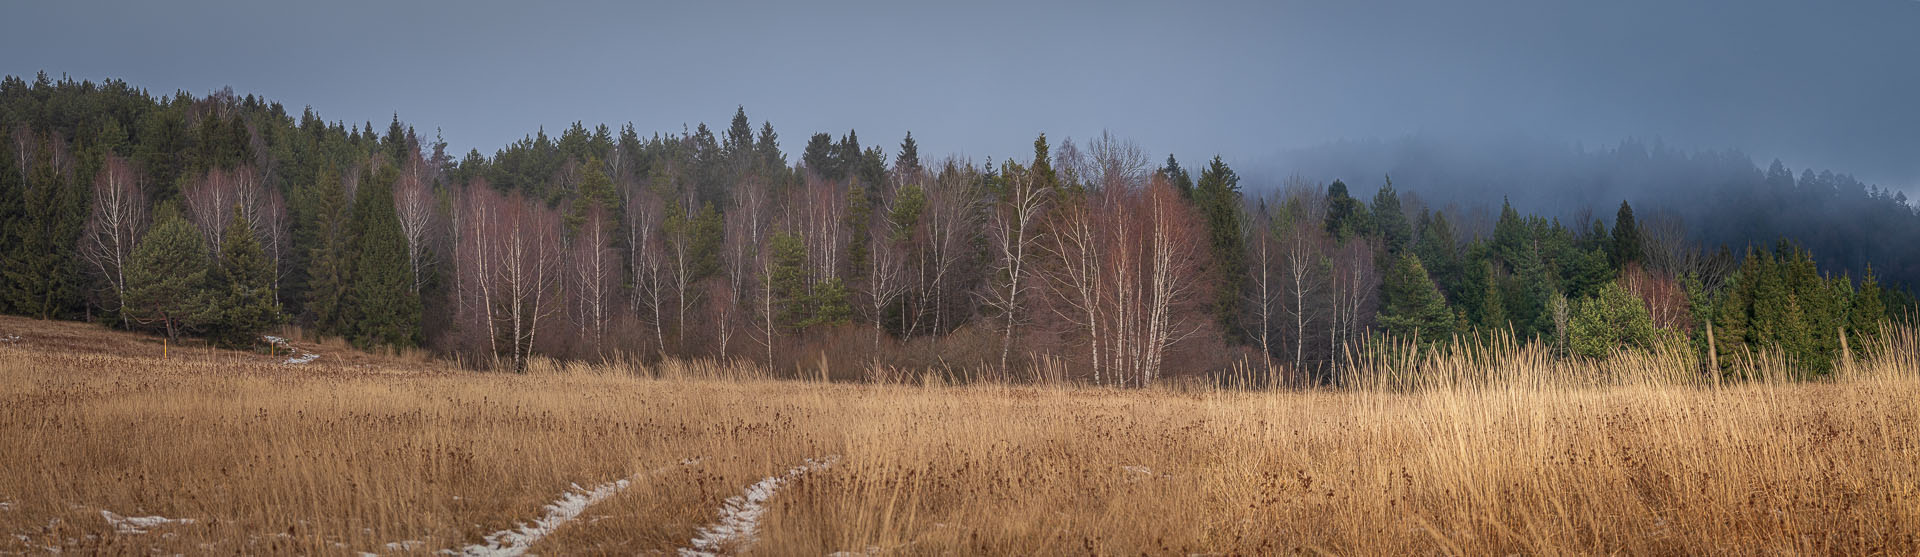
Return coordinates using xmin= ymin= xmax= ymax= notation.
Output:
xmin=346 ymin=167 xmax=420 ymax=348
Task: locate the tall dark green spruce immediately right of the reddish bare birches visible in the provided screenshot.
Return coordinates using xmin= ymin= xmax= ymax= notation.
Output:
xmin=1194 ymin=156 xmax=1246 ymax=340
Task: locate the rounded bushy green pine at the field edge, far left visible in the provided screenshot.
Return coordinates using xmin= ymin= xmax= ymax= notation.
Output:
xmin=127 ymin=206 xmax=209 ymax=340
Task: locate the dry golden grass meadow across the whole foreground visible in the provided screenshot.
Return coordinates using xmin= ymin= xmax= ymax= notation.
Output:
xmin=0 ymin=319 xmax=1920 ymax=555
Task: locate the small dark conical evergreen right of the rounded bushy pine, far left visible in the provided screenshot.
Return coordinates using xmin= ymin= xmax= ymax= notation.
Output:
xmin=207 ymin=209 xmax=282 ymax=348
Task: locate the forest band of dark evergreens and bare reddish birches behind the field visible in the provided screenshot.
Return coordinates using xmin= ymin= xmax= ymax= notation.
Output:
xmin=0 ymin=73 xmax=1920 ymax=386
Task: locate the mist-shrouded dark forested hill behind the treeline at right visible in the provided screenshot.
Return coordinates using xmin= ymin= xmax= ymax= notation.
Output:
xmin=1244 ymin=134 xmax=1920 ymax=286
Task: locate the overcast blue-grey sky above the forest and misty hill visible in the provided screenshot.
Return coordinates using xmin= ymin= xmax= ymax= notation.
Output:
xmin=0 ymin=0 xmax=1920 ymax=192
